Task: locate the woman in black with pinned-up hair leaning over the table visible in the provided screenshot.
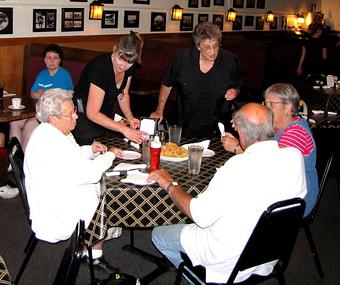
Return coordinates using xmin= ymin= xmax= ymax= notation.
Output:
xmin=73 ymin=31 xmax=144 ymax=144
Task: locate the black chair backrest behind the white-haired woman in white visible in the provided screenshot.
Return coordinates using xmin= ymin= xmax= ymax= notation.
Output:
xmin=8 ymin=137 xmax=29 ymax=218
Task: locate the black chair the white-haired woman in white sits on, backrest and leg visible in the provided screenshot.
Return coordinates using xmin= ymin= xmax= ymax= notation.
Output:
xmin=8 ymin=137 xmax=39 ymax=284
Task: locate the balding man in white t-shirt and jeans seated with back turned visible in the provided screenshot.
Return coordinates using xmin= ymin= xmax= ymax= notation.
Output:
xmin=148 ymin=103 xmax=306 ymax=283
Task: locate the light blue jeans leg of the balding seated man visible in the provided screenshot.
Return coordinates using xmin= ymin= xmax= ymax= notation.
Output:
xmin=152 ymin=224 xmax=186 ymax=268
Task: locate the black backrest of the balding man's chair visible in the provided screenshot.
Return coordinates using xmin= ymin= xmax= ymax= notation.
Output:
xmin=227 ymin=198 xmax=305 ymax=284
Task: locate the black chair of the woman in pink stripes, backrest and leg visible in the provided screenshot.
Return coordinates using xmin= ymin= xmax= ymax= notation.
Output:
xmin=301 ymin=154 xmax=333 ymax=277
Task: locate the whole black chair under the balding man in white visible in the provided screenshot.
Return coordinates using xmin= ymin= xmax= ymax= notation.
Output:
xmin=175 ymin=198 xmax=305 ymax=285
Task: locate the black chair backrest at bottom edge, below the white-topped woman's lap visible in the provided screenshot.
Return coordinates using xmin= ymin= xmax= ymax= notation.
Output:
xmin=53 ymin=220 xmax=85 ymax=285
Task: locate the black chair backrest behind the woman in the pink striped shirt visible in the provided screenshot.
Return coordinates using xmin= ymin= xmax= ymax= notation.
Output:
xmin=305 ymin=154 xmax=334 ymax=222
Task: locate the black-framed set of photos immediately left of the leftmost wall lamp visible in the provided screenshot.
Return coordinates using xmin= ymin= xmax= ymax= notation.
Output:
xmin=61 ymin=8 xmax=84 ymax=32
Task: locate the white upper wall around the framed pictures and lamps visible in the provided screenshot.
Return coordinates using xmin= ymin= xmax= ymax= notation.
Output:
xmin=0 ymin=0 xmax=330 ymax=38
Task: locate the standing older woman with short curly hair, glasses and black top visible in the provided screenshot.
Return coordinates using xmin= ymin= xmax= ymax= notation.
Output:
xmin=151 ymin=22 xmax=240 ymax=138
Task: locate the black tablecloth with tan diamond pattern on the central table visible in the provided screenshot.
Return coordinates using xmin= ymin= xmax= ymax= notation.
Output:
xmin=85 ymin=135 xmax=231 ymax=246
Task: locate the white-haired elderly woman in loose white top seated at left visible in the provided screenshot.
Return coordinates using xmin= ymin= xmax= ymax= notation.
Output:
xmin=24 ymin=89 xmax=121 ymax=272
